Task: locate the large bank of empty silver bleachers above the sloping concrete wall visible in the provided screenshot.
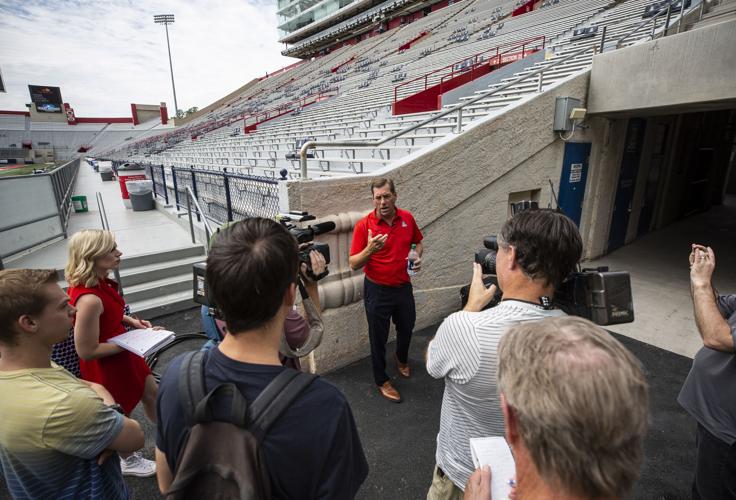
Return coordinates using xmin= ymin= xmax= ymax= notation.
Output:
xmin=102 ymin=0 xmax=684 ymax=182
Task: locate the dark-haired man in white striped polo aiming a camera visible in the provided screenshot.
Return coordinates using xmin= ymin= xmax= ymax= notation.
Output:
xmin=427 ymin=210 xmax=582 ymax=500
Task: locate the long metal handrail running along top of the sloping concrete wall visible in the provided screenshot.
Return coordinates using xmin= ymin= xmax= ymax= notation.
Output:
xmin=299 ymin=0 xmax=684 ymax=180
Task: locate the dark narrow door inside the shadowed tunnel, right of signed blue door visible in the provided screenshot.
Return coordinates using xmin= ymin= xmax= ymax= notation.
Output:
xmin=608 ymin=118 xmax=647 ymax=252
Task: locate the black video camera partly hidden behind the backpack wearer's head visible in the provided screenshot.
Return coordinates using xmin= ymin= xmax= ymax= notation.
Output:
xmin=193 ymin=211 xmax=335 ymax=309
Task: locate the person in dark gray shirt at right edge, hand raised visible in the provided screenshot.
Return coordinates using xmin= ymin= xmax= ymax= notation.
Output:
xmin=677 ymin=244 xmax=736 ymax=499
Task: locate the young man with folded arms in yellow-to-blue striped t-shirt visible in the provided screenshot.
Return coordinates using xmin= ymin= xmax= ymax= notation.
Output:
xmin=0 ymin=269 xmax=144 ymax=500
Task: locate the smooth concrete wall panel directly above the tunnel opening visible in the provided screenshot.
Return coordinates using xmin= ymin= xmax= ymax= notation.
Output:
xmin=588 ymin=21 xmax=736 ymax=114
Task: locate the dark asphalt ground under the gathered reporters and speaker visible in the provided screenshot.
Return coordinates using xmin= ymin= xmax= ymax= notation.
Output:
xmin=0 ymin=309 xmax=696 ymax=500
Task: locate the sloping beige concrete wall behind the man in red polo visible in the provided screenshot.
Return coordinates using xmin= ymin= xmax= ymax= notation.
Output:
xmin=288 ymin=73 xmax=590 ymax=372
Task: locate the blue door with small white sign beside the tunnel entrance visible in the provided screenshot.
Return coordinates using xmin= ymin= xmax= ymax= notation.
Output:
xmin=558 ymin=142 xmax=590 ymax=227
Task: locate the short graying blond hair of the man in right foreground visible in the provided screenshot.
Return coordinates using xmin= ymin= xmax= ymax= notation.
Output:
xmin=498 ymin=317 xmax=649 ymax=498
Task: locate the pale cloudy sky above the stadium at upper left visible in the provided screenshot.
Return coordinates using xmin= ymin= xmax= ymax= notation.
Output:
xmin=0 ymin=0 xmax=296 ymax=117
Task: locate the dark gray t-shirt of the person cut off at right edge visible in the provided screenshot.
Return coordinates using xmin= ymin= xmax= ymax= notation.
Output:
xmin=677 ymin=295 xmax=736 ymax=445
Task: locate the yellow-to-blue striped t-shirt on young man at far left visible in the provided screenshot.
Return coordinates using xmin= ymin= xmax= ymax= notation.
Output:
xmin=0 ymin=364 xmax=128 ymax=500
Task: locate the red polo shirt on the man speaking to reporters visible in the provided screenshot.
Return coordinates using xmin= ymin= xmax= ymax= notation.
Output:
xmin=350 ymin=208 xmax=422 ymax=286
